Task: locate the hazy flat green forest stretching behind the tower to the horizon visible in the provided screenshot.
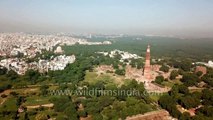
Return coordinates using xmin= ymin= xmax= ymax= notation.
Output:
xmin=64 ymin=36 xmax=213 ymax=61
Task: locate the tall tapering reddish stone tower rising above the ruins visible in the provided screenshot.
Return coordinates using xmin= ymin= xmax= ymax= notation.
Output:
xmin=143 ymin=45 xmax=151 ymax=80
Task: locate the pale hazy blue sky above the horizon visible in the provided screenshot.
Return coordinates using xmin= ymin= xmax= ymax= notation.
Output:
xmin=0 ymin=0 xmax=213 ymax=37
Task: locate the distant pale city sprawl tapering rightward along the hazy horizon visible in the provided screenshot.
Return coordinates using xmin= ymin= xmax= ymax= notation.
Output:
xmin=0 ymin=33 xmax=112 ymax=58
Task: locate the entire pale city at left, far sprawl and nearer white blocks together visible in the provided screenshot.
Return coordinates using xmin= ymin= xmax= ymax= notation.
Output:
xmin=0 ymin=33 xmax=112 ymax=75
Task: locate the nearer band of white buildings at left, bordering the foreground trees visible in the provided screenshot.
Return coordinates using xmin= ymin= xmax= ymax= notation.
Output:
xmin=0 ymin=55 xmax=76 ymax=75
